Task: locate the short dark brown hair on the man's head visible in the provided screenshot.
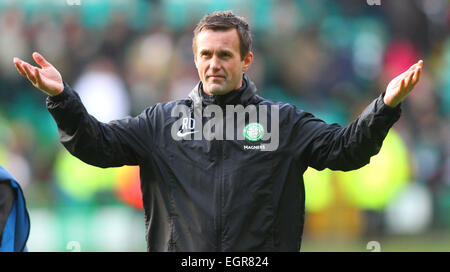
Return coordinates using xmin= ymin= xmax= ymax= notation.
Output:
xmin=192 ymin=10 xmax=252 ymax=59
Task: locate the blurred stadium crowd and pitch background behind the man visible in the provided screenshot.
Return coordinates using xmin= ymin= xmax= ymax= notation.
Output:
xmin=0 ymin=0 xmax=450 ymax=251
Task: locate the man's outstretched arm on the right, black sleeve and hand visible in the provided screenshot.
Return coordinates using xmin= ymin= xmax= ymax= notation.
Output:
xmin=296 ymin=61 xmax=423 ymax=170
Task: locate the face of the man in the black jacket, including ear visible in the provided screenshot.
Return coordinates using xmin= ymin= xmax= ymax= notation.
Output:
xmin=194 ymin=28 xmax=253 ymax=95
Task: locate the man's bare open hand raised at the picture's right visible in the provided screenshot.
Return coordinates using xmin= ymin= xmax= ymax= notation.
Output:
xmin=384 ymin=60 xmax=423 ymax=107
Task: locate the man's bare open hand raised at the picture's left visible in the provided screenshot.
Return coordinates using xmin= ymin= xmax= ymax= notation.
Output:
xmin=14 ymin=52 xmax=64 ymax=96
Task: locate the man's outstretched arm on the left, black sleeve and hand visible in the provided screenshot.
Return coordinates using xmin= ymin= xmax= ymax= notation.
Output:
xmin=14 ymin=52 xmax=151 ymax=167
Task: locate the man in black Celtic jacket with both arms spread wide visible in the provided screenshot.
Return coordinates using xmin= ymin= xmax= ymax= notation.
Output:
xmin=14 ymin=12 xmax=422 ymax=251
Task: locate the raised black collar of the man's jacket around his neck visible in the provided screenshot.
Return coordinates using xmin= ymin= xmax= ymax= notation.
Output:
xmin=189 ymin=73 xmax=257 ymax=107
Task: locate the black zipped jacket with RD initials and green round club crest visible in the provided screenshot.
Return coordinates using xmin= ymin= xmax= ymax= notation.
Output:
xmin=47 ymin=75 xmax=400 ymax=251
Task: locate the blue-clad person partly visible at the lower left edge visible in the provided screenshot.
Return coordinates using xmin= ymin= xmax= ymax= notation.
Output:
xmin=0 ymin=166 xmax=30 ymax=252
